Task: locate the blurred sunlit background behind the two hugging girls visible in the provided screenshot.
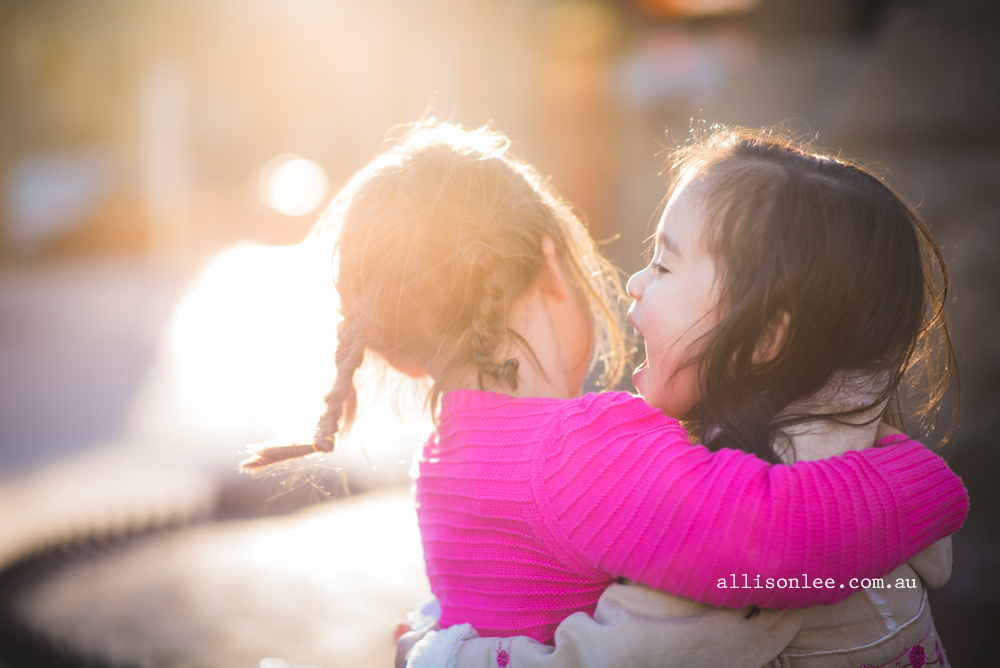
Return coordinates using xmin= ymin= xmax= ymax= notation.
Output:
xmin=0 ymin=0 xmax=1000 ymax=668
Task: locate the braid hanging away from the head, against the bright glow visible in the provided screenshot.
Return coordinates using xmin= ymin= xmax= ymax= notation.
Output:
xmin=240 ymin=319 xmax=365 ymax=469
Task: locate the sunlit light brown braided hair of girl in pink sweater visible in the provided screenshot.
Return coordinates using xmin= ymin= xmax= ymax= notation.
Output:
xmin=242 ymin=122 xmax=625 ymax=468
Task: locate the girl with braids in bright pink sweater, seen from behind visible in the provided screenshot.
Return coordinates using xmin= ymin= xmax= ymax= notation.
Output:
xmin=238 ymin=120 xmax=967 ymax=641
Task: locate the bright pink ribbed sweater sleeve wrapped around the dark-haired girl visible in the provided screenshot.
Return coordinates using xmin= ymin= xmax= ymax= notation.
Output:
xmin=532 ymin=393 xmax=968 ymax=610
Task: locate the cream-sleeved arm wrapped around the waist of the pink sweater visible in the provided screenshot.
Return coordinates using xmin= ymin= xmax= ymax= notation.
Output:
xmin=406 ymin=585 xmax=801 ymax=668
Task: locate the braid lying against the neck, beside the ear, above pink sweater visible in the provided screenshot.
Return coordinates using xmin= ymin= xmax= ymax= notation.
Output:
xmin=470 ymin=251 xmax=520 ymax=390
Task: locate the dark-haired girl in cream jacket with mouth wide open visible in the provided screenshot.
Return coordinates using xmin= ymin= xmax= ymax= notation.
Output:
xmin=412 ymin=128 xmax=951 ymax=668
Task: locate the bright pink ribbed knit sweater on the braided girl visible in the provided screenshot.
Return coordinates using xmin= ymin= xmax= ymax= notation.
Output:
xmin=417 ymin=391 xmax=968 ymax=642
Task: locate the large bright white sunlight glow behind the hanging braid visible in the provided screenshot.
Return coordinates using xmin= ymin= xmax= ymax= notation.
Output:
xmin=136 ymin=239 xmax=432 ymax=485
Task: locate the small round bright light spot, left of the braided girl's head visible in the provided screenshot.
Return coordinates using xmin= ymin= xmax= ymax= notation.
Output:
xmin=257 ymin=153 xmax=328 ymax=216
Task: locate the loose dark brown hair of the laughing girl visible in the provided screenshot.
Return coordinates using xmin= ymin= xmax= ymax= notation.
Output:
xmin=671 ymin=126 xmax=957 ymax=462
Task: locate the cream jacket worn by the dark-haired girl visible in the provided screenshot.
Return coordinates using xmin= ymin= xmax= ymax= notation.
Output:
xmin=407 ymin=538 xmax=951 ymax=668
